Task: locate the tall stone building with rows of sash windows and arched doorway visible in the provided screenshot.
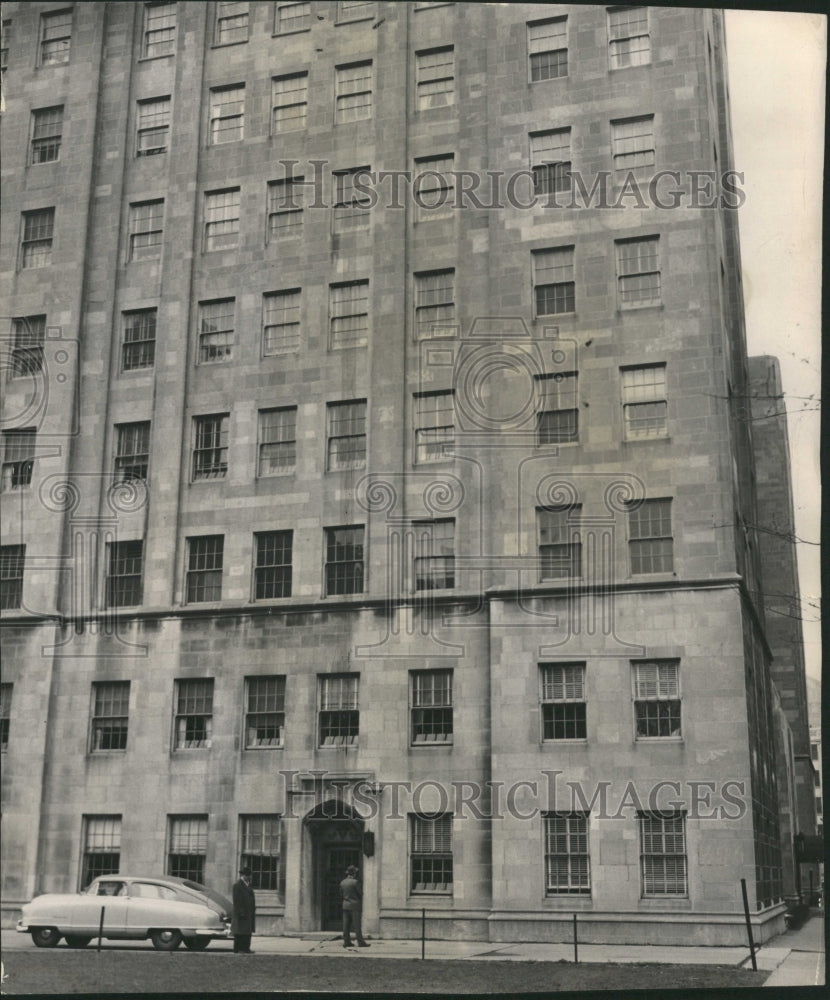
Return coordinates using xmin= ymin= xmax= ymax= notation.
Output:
xmin=2 ymin=2 xmax=820 ymax=944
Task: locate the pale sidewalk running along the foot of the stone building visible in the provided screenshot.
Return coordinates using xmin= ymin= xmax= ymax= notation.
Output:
xmin=1 ymin=910 xmax=825 ymax=987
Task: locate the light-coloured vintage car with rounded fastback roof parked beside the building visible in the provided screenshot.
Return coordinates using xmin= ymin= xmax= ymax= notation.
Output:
xmin=17 ymin=875 xmax=233 ymax=951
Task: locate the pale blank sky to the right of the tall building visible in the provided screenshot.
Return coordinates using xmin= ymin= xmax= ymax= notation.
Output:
xmin=726 ymin=10 xmax=827 ymax=677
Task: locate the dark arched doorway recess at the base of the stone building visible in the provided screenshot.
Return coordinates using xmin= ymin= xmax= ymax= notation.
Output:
xmin=303 ymin=799 xmax=363 ymax=931
